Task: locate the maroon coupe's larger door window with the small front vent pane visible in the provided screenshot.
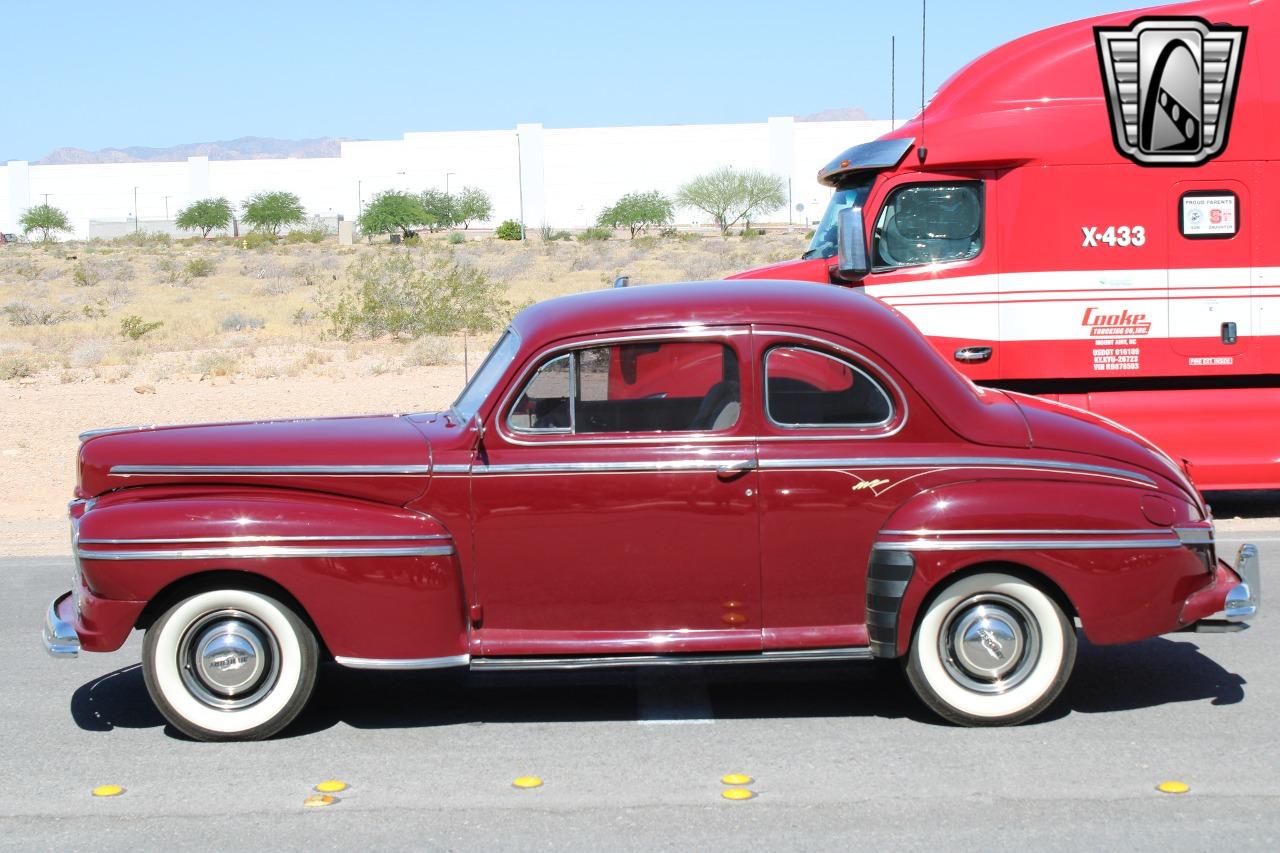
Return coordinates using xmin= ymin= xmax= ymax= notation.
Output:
xmin=507 ymin=341 xmax=741 ymax=434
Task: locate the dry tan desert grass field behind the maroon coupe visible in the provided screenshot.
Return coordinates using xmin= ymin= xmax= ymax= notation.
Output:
xmin=0 ymin=234 xmax=804 ymax=383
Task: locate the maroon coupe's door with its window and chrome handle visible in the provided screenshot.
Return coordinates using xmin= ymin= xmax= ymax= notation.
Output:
xmin=472 ymin=328 xmax=760 ymax=656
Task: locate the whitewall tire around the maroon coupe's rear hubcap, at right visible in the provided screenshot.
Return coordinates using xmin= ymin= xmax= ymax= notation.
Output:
xmin=906 ymin=573 xmax=1076 ymax=726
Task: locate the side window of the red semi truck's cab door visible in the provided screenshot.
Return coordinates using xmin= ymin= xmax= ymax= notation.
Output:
xmin=873 ymin=181 xmax=983 ymax=269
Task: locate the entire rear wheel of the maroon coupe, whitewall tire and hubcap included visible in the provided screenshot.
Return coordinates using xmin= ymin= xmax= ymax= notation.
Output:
xmin=906 ymin=574 xmax=1075 ymax=726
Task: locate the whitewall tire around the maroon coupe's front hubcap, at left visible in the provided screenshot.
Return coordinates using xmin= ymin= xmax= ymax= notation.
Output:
xmin=142 ymin=589 xmax=320 ymax=740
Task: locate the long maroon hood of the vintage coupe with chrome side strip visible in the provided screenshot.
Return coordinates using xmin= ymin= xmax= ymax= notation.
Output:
xmin=83 ymin=415 xmax=431 ymax=505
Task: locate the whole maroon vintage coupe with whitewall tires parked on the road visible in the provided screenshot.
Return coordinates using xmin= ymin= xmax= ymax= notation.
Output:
xmin=45 ymin=282 xmax=1258 ymax=739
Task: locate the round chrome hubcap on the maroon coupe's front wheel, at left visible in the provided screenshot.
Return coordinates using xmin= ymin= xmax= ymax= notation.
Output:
xmin=178 ymin=610 xmax=280 ymax=711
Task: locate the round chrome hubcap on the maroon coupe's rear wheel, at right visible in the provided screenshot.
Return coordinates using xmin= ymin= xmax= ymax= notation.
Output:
xmin=938 ymin=593 xmax=1041 ymax=693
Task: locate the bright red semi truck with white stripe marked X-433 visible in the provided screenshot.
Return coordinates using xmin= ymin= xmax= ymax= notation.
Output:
xmin=731 ymin=0 xmax=1280 ymax=489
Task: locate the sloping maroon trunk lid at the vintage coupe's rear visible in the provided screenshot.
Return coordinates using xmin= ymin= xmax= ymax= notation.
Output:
xmin=1005 ymin=392 xmax=1208 ymax=514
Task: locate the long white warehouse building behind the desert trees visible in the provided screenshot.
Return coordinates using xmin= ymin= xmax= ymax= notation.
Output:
xmin=0 ymin=117 xmax=890 ymax=238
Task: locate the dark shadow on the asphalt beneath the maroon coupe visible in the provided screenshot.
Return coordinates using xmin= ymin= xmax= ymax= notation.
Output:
xmin=70 ymin=638 xmax=1245 ymax=739
